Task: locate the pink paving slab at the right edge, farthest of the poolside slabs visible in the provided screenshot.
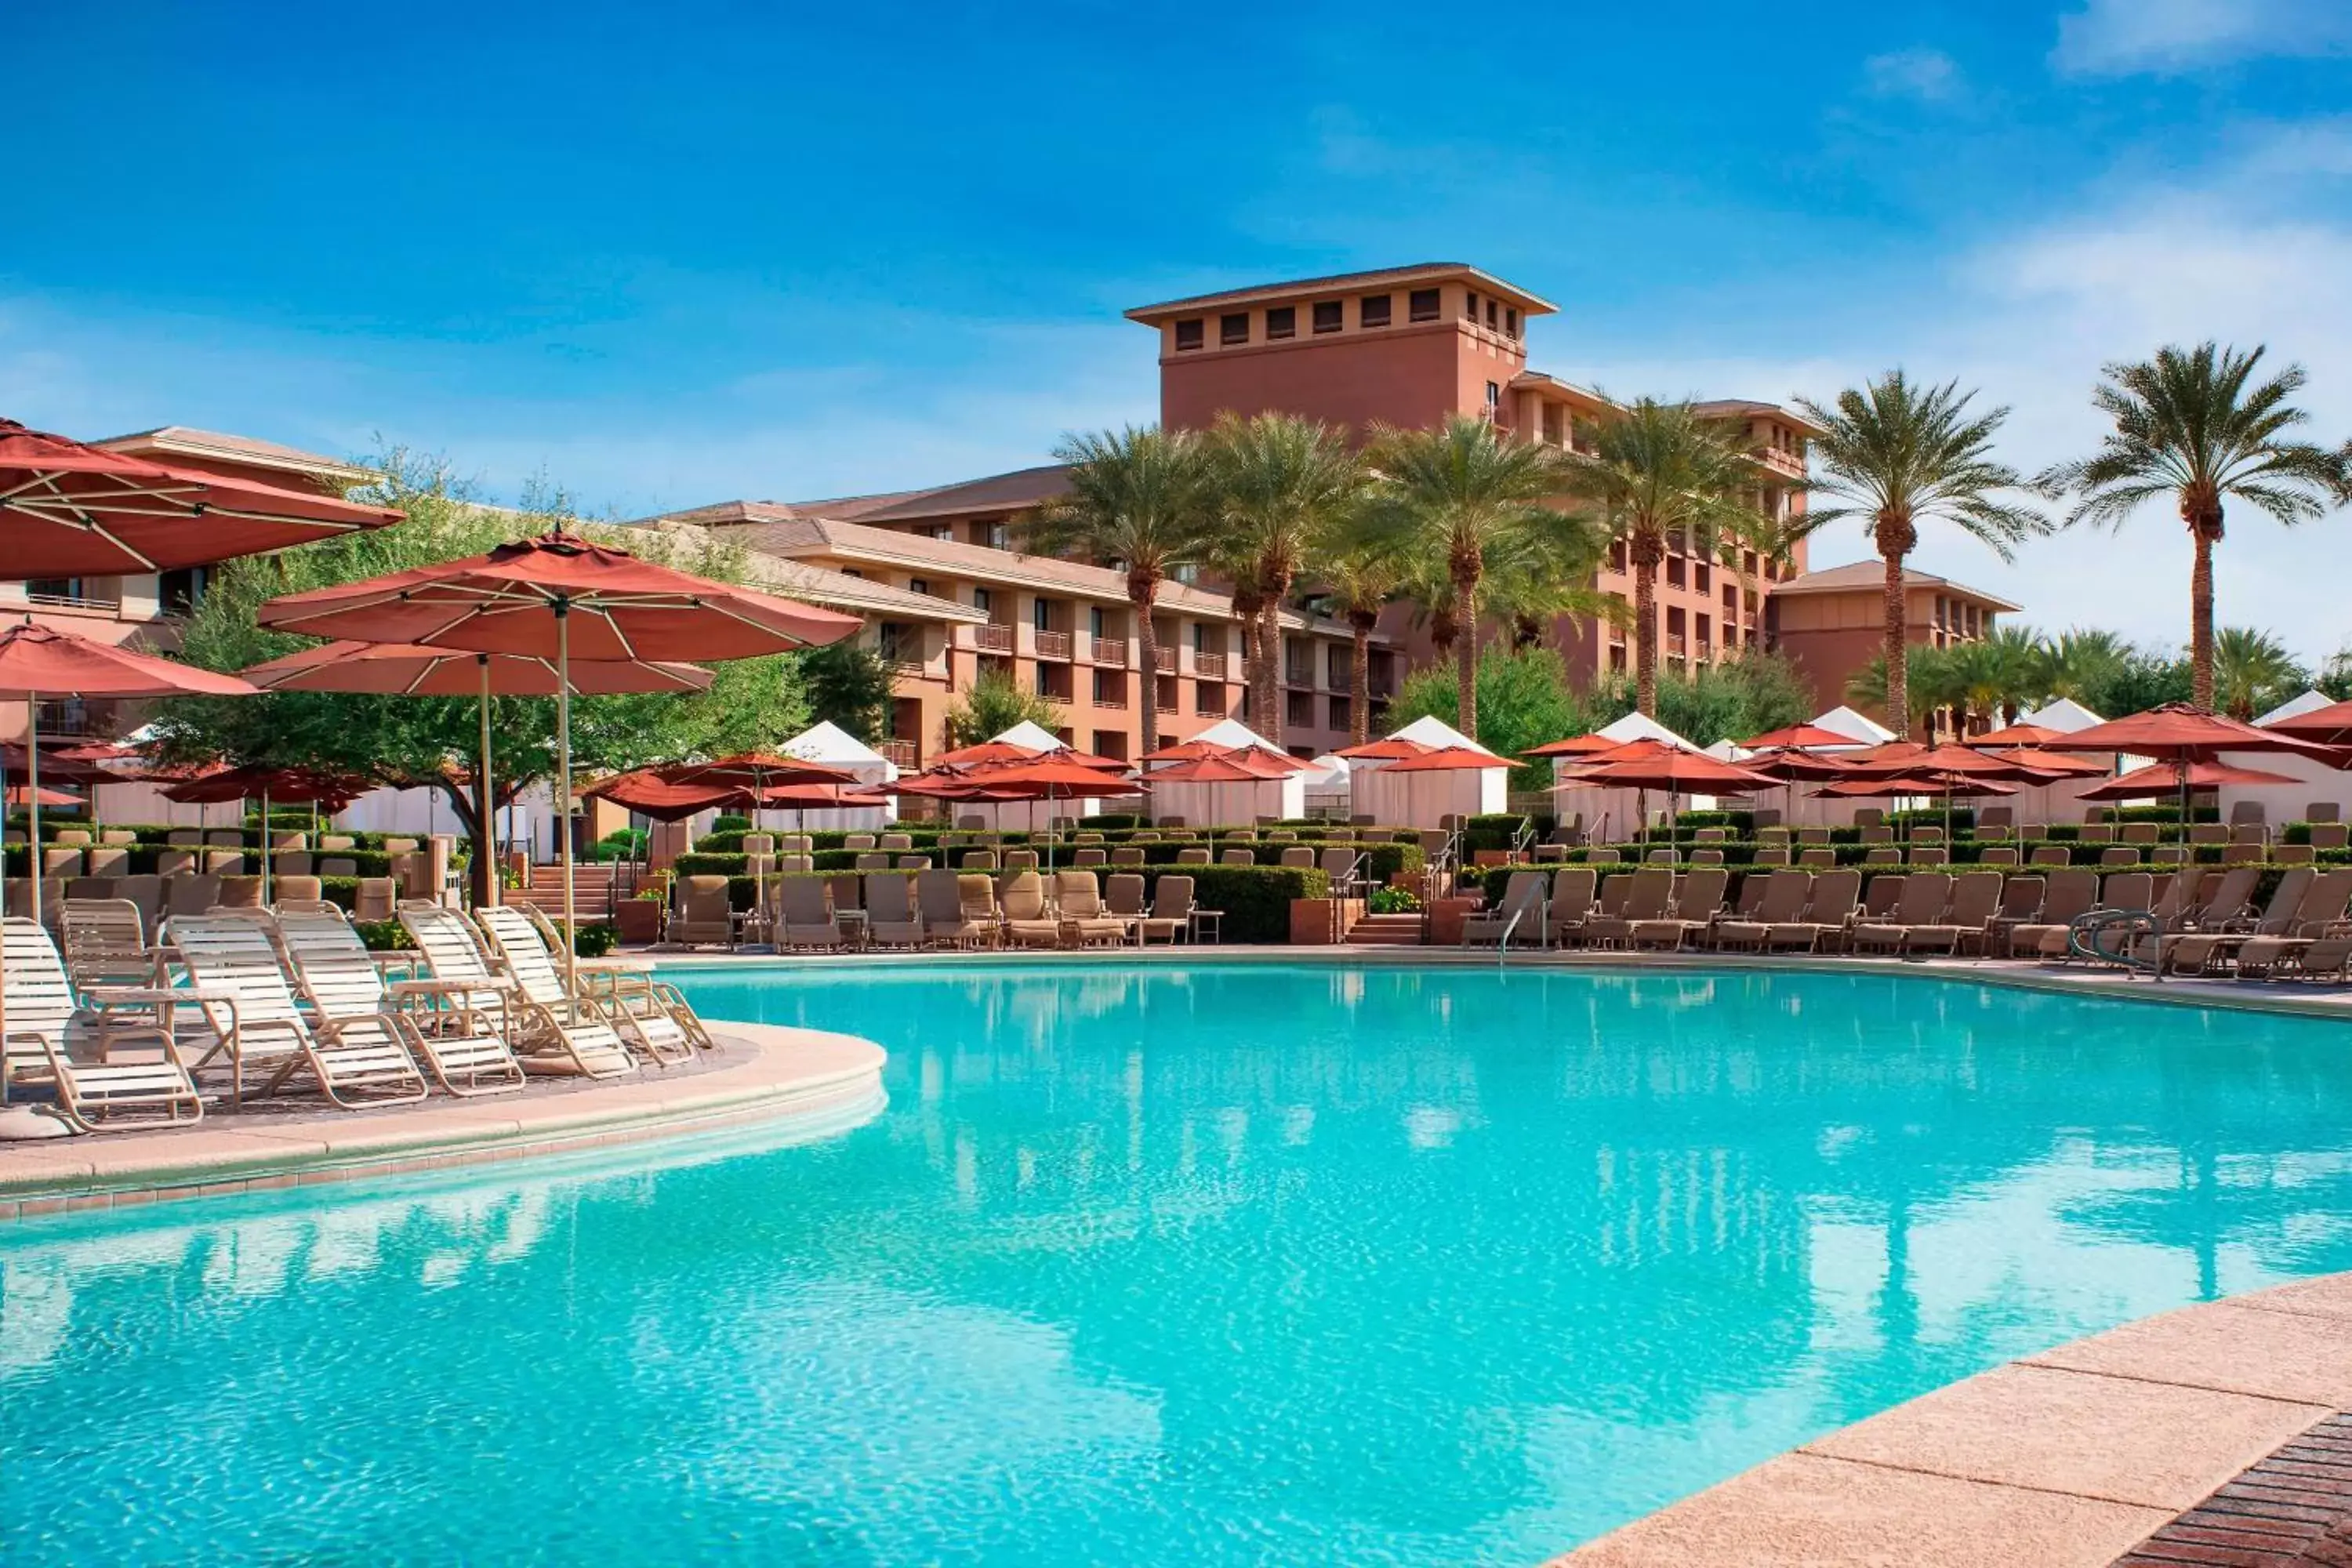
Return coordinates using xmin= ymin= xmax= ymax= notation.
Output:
xmin=2027 ymin=1302 xmax=2352 ymax=1410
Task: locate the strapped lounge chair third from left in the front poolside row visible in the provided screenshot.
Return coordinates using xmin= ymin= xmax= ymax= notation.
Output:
xmin=278 ymin=912 xmax=522 ymax=1098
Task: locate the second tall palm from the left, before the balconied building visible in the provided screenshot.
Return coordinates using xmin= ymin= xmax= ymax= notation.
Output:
xmin=1207 ymin=412 xmax=1364 ymax=741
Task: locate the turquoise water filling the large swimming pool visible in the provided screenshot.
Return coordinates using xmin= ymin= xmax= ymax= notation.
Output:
xmin=0 ymin=966 xmax=2352 ymax=1566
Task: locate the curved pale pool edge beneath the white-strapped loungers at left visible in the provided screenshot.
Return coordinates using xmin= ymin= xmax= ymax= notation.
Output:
xmin=0 ymin=1022 xmax=887 ymax=1222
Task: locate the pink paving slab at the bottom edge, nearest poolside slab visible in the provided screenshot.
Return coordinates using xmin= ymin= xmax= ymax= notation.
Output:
xmin=1555 ymin=1453 xmax=2176 ymax=1568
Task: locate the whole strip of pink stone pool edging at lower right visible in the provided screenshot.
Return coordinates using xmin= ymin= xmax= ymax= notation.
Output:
xmin=1548 ymin=1274 xmax=2352 ymax=1568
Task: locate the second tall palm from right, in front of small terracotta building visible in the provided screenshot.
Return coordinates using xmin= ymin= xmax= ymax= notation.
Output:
xmin=1797 ymin=369 xmax=2051 ymax=734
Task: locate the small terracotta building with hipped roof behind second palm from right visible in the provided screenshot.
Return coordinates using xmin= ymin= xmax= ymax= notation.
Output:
xmin=1764 ymin=560 xmax=2018 ymax=717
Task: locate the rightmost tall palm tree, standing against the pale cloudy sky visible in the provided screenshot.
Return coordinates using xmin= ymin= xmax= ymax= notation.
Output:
xmin=2039 ymin=341 xmax=2347 ymax=708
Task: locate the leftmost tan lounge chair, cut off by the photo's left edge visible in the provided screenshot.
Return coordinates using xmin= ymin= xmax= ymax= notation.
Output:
xmin=0 ymin=916 xmax=205 ymax=1133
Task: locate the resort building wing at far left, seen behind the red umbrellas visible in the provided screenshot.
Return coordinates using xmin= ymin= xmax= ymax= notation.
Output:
xmin=0 ymin=426 xmax=376 ymax=741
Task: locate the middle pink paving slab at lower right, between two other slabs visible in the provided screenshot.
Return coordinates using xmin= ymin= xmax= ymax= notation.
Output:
xmin=1804 ymin=1366 xmax=2328 ymax=1512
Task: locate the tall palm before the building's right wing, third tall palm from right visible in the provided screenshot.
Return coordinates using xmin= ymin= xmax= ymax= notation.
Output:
xmin=1569 ymin=397 xmax=1759 ymax=717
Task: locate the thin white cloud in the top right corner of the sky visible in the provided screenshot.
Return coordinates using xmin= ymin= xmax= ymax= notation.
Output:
xmin=2051 ymin=0 xmax=2352 ymax=75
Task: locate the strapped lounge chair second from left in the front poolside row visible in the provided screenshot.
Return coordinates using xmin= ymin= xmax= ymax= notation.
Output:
xmin=169 ymin=914 xmax=430 ymax=1109
